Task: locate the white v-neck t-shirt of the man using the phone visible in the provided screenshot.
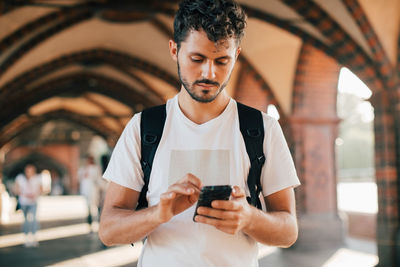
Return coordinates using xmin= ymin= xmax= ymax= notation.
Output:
xmin=104 ymin=96 xmax=299 ymax=267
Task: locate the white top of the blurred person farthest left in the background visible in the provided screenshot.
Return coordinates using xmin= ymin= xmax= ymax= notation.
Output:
xmin=15 ymin=174 xmax=42 ymax=205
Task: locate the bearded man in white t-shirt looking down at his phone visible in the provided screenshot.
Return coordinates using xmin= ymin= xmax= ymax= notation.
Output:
xmin=99 ymin=0 xmax=299 ymax=266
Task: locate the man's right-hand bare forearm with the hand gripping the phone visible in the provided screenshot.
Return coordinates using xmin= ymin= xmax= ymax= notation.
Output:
xmin=196 ymin=187 xmax=298 ymax=247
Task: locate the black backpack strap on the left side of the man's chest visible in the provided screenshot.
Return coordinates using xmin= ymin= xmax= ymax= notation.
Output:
xmin=136 ymin=104 xmax=167 ymax=209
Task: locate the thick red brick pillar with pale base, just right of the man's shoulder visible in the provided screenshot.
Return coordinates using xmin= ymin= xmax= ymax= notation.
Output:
xmin=290 ymin=44 xmax=344 ymax=248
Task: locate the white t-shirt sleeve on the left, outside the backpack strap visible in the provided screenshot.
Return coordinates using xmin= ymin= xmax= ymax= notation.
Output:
xmin=103 ymin=113 xmax=144 ymax=192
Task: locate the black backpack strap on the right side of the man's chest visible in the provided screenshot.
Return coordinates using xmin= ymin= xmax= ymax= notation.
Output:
xmin=237 ymin=103 xmax=265 ymax=209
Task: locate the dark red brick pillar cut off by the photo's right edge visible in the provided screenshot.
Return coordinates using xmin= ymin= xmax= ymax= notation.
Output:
xmin=371 ymin=85 xmax=400 ymax=267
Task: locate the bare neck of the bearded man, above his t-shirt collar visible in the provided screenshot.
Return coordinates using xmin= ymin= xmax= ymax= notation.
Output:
xmin=178 ymin=87 xmax=230 ymax=124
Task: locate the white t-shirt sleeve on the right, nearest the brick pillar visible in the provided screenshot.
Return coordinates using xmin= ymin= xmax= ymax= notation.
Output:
xmin=261 ymin=114 xmax=300 ymax=197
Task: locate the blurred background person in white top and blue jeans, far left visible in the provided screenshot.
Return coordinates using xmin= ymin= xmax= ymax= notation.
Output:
xmin=15 ymin=164 xmax=43 ymax=247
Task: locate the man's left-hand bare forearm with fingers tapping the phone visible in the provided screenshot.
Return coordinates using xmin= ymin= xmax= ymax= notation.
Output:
xmin=99 ymin=174 xmax=201 ymax=246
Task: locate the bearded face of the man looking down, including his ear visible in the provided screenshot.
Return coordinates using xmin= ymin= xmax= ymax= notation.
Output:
xmin=170 ymin=30 xmax=240 ymax=103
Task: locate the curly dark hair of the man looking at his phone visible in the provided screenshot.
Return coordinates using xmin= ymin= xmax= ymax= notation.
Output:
xmin=174 ymin=0 xmax=247 ymax=49
